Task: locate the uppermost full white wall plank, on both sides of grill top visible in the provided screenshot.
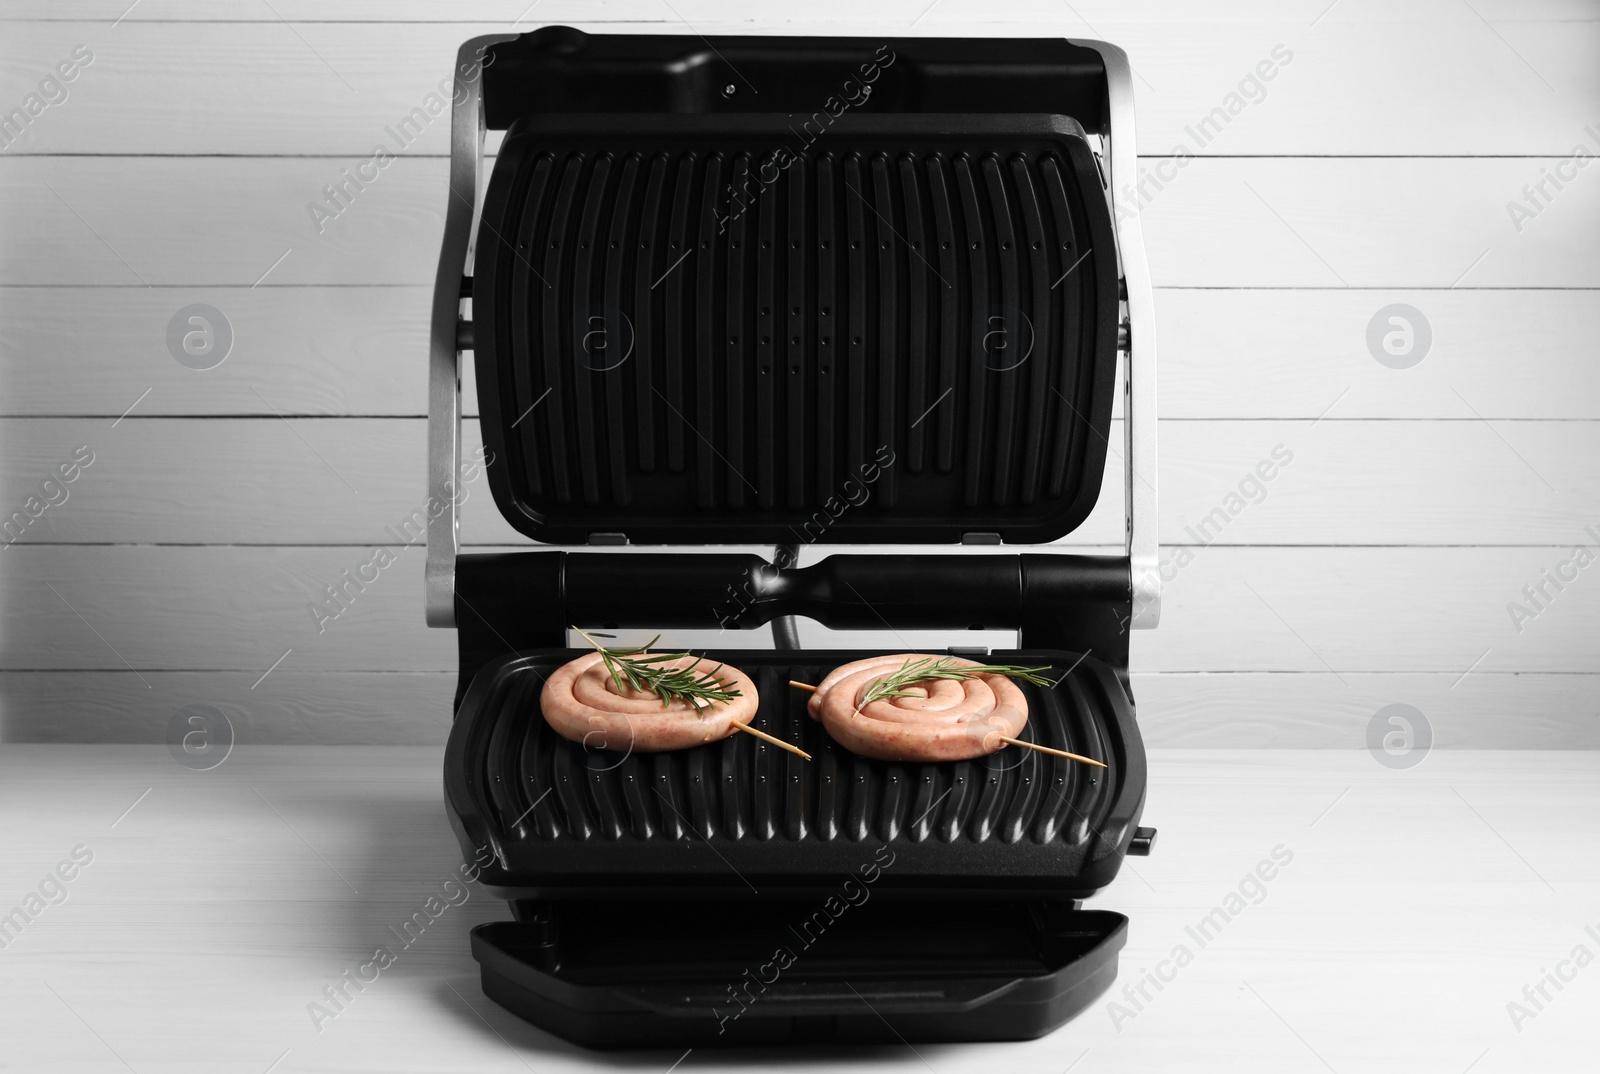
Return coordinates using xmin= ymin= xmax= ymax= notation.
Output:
xmin=0 ymin=14 xmax=1600 ymax=157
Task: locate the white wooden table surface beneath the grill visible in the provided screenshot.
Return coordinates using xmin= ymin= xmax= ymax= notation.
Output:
xmin=0 ymin=746 xmax=1600 ymax=1074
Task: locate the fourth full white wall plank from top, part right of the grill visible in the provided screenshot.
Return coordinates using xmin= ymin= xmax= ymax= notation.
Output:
xmin=1132 ymin=419 xmax=1600 ymax=546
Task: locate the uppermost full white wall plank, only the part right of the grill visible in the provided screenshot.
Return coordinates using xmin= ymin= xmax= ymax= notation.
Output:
xmin=1096 ymin=15 xmax=1600 ymax=157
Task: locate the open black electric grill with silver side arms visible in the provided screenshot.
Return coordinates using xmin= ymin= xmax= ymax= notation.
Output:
xmin=427 ymin=27 xmax=1158 ymax=1047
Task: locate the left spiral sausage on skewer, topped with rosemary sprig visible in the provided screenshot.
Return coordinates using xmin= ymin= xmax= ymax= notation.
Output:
xmin=539 ymin=653 xmax=758 ymax=754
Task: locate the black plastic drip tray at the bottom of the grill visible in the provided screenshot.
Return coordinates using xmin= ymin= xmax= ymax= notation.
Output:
xmin=472 ymin=887 xmax=1126 ymax=1048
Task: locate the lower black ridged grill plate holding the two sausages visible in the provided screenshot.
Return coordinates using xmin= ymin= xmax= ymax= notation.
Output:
xmin=445 ymin=650 xmax=1144 ymax=893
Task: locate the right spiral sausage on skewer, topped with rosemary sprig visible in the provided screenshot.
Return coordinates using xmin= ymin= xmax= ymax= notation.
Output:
xmin=806 ymin=653 xmax=1027 ymax=760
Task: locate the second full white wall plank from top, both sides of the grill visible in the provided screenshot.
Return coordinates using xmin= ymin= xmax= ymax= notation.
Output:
xmin=9 ymin=157 xmax=1600 ymax=288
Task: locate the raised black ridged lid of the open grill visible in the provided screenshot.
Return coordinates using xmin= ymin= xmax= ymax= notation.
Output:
xmin=472 ymin=29 xmax=1118 ymax=544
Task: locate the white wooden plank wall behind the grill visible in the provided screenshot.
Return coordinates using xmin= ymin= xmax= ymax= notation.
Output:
xmin=0 ymin=0 xmax=1600 ymax=747
